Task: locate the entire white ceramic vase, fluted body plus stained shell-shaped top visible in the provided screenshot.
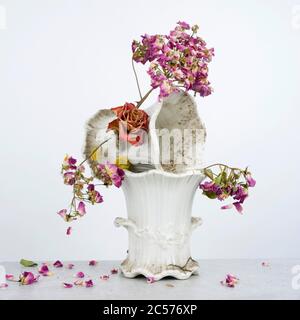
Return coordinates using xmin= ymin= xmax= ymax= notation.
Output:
xmin=84 ymin=91 xmax=206 ymax=280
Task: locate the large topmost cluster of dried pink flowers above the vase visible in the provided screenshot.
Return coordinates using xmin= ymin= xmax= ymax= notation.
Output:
xmin=132 ymin=21 xmax=214 ymax=99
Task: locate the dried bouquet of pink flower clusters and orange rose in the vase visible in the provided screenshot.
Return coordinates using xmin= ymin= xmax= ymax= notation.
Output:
xmin=58 ymin=22 xmax=256 ymax=234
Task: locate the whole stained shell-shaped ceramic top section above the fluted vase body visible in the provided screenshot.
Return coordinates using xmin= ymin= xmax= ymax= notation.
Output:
xmin=84 ymin=91 xmax=206 ymax=173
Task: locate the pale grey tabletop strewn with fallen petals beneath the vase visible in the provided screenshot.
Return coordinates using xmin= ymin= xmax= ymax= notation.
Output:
xmin=0 ymin=259 xmax=300 ymax=300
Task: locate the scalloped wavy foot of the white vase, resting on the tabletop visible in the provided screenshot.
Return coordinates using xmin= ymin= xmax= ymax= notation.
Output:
xmin=120 ymin=258 xmax=199 ymax=281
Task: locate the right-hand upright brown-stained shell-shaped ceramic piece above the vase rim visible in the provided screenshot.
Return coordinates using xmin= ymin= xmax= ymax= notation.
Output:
xmin=146 ymin=91 xmax=206 ymax=173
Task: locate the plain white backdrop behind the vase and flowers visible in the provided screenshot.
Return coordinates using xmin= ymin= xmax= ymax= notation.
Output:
xmin=0 ymin=0 xmax=300 ymax=261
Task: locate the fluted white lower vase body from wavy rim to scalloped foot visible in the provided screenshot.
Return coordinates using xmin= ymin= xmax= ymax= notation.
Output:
xmin=115 ymin=170 xmax=204 ymax=280
